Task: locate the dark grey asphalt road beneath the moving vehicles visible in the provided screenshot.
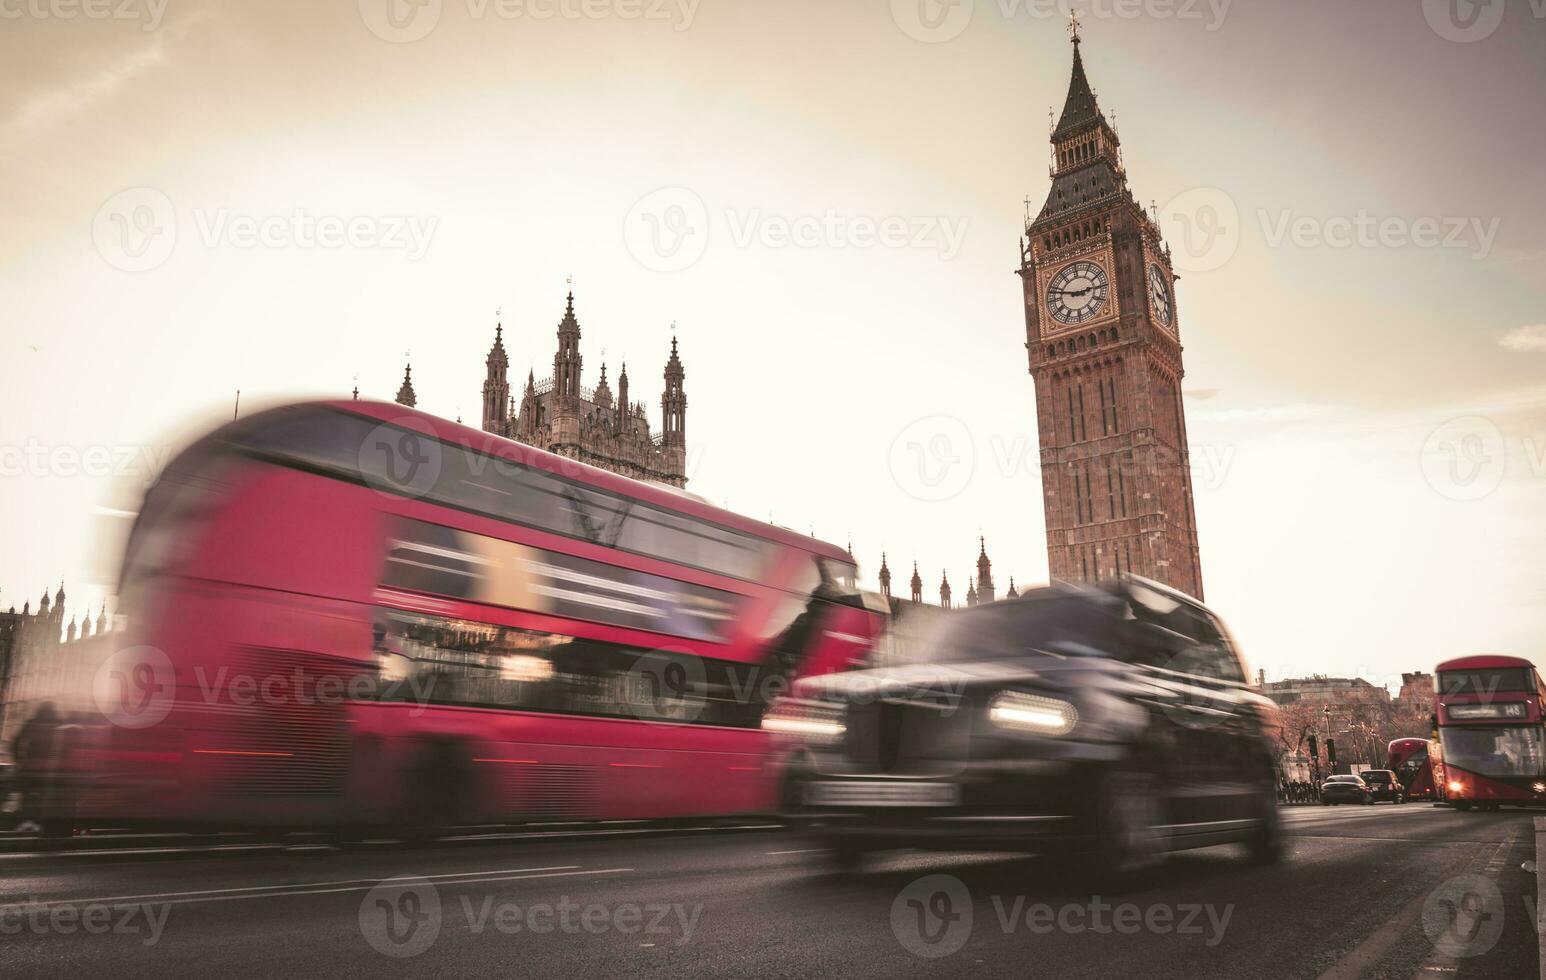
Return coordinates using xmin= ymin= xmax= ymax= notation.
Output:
xmin=0 ymin=804 xmax=1538 ymax=980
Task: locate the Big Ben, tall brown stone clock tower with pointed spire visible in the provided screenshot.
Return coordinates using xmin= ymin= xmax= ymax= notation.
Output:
xmin=1019 ymin=22 xmax=1203 ymax=598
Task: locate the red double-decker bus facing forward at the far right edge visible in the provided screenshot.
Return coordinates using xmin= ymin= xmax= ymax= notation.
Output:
xmin=1433 ymin=655 xmax=1546 ymax=810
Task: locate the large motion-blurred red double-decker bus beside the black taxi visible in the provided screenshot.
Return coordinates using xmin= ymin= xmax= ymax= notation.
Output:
xmin=24 ymin=402 xmax=881 ymax=832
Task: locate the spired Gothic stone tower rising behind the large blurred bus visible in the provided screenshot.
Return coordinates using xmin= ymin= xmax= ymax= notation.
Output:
xmin=482 ymin=292 xmax=686 ymax=487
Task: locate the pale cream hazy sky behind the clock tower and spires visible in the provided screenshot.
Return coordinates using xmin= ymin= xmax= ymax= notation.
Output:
xmin=0 ymin=0 xmax=1546 ymax=682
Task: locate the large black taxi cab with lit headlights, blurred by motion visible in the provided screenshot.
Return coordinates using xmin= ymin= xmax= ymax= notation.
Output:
xmin=764 ymin=577 xmax=1280 ymax=883
